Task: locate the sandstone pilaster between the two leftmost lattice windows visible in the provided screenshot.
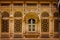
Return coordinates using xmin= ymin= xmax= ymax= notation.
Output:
xmin=10 ymin=2 xmax=14 ymax=38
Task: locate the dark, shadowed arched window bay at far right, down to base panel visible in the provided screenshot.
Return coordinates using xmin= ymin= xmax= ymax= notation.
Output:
xmin=54 ymin=12 xmax=59 ymax=38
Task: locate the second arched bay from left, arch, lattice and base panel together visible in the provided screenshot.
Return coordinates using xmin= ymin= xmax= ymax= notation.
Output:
xmin=14 ymin=11 xmax=22 ymax=38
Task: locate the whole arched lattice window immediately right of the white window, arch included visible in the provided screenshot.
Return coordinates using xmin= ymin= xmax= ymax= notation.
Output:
xmin=41 ymin=12 xmax=49 ymax=32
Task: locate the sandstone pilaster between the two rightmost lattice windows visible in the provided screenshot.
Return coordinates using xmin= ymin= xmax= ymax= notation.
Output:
xmin=49 ymin=3 xmax=54 ymax=38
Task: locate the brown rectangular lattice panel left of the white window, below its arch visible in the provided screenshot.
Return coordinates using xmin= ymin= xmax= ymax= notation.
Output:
xmin=14 ymin=19 xmax=22 ymax=32
